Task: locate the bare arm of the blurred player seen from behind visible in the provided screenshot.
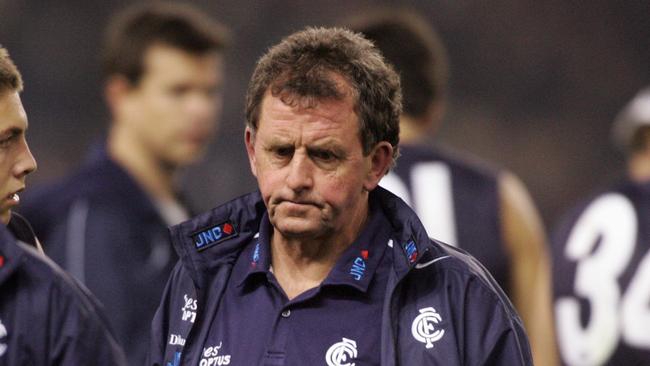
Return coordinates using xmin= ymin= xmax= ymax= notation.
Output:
xmin=499 ymin=172 xmax=558 ymax=366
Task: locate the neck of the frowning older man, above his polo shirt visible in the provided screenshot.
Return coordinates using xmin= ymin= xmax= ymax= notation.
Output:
xmin=271 ymin=199 xmax=368 ymax=300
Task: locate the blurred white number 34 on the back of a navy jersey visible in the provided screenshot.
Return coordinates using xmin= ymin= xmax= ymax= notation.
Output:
xmin=555 ymin=193 xmax=650 ymax=365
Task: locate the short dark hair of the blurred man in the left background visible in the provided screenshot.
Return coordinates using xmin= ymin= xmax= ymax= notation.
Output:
xmin=102 ymin=2 xmax=229 ymax=84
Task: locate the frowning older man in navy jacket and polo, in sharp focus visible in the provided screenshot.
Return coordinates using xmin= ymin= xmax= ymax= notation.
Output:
xmin=149 ymin=28 xmax=531 ymax=366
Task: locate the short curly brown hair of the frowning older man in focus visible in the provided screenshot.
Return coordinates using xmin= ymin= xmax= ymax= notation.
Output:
xmin=246 ymin=27 xmax=402 ymax=164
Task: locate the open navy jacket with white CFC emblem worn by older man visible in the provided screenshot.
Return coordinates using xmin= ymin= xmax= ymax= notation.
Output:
xmin=147 ymin=188 xmax=532 ymax=366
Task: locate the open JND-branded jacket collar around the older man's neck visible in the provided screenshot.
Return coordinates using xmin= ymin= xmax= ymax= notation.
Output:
xmin=170 ymin=187 xmax=446 ymax=288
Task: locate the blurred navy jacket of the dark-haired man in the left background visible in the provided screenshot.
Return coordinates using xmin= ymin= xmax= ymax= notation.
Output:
xmin=19 ymin=149 xmax=177 ymax=365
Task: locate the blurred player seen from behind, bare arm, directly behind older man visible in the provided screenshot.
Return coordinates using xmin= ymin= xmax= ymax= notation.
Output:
xmin=346 ymin=8 xmax=557 ymax=365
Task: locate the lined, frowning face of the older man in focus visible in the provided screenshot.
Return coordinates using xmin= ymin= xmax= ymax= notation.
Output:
xmin=246 ymin=85 xmax=390 ymax=238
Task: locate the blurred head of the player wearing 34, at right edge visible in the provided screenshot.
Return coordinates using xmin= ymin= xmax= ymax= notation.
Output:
xmin=612 ymin=87 xmax=650 ymax=155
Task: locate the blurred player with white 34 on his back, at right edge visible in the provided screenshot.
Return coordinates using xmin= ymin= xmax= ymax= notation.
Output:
xmin=553 ymin=87 xmax=650 ymax=366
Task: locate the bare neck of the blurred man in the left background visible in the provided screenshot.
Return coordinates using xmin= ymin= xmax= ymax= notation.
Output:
xmin=107 ymin=124 xmax=176 ymax=202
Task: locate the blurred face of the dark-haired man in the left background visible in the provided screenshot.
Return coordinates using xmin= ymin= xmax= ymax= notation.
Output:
xmin=117 ymin=45 xmax=222 ymax=166
